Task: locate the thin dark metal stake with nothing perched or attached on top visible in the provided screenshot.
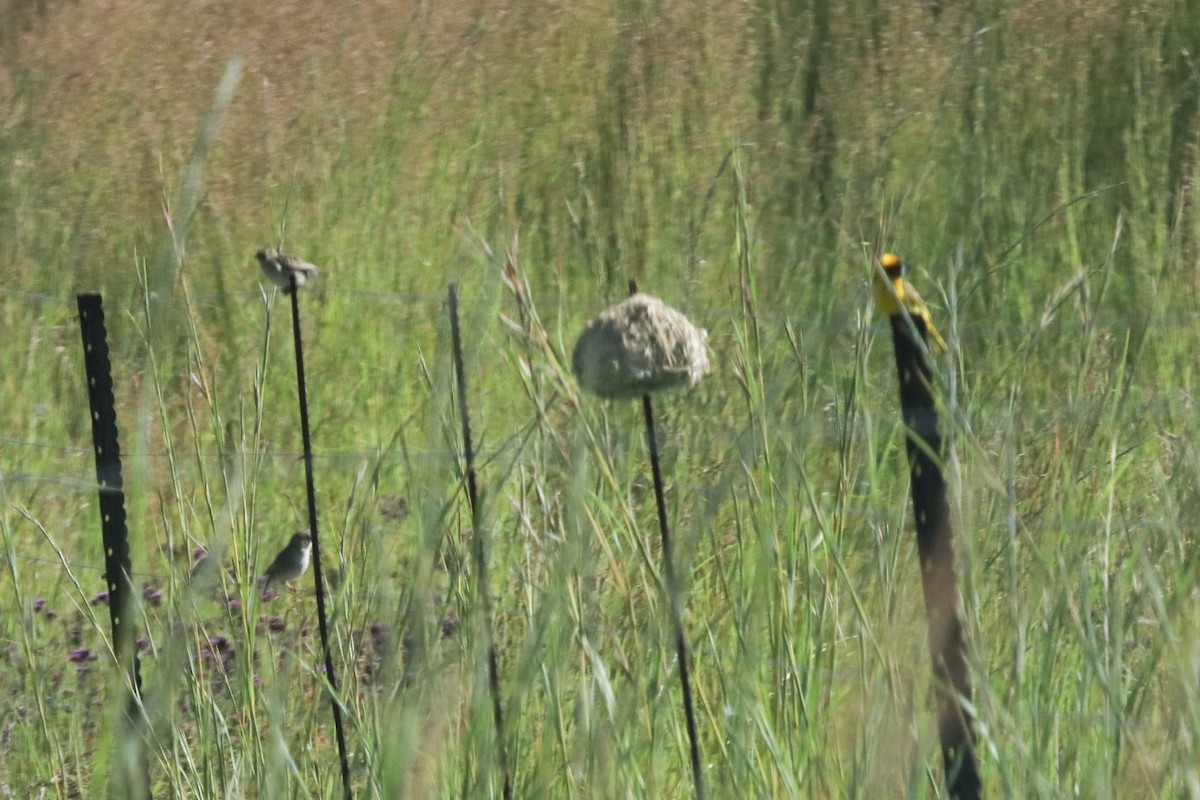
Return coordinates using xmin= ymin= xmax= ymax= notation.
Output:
xmin=449 ymin=283 xmax=512 ymax=800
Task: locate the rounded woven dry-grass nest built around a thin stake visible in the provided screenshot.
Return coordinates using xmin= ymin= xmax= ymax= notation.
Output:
xmin=571 ymin=293 xmax=709 ymax=399
